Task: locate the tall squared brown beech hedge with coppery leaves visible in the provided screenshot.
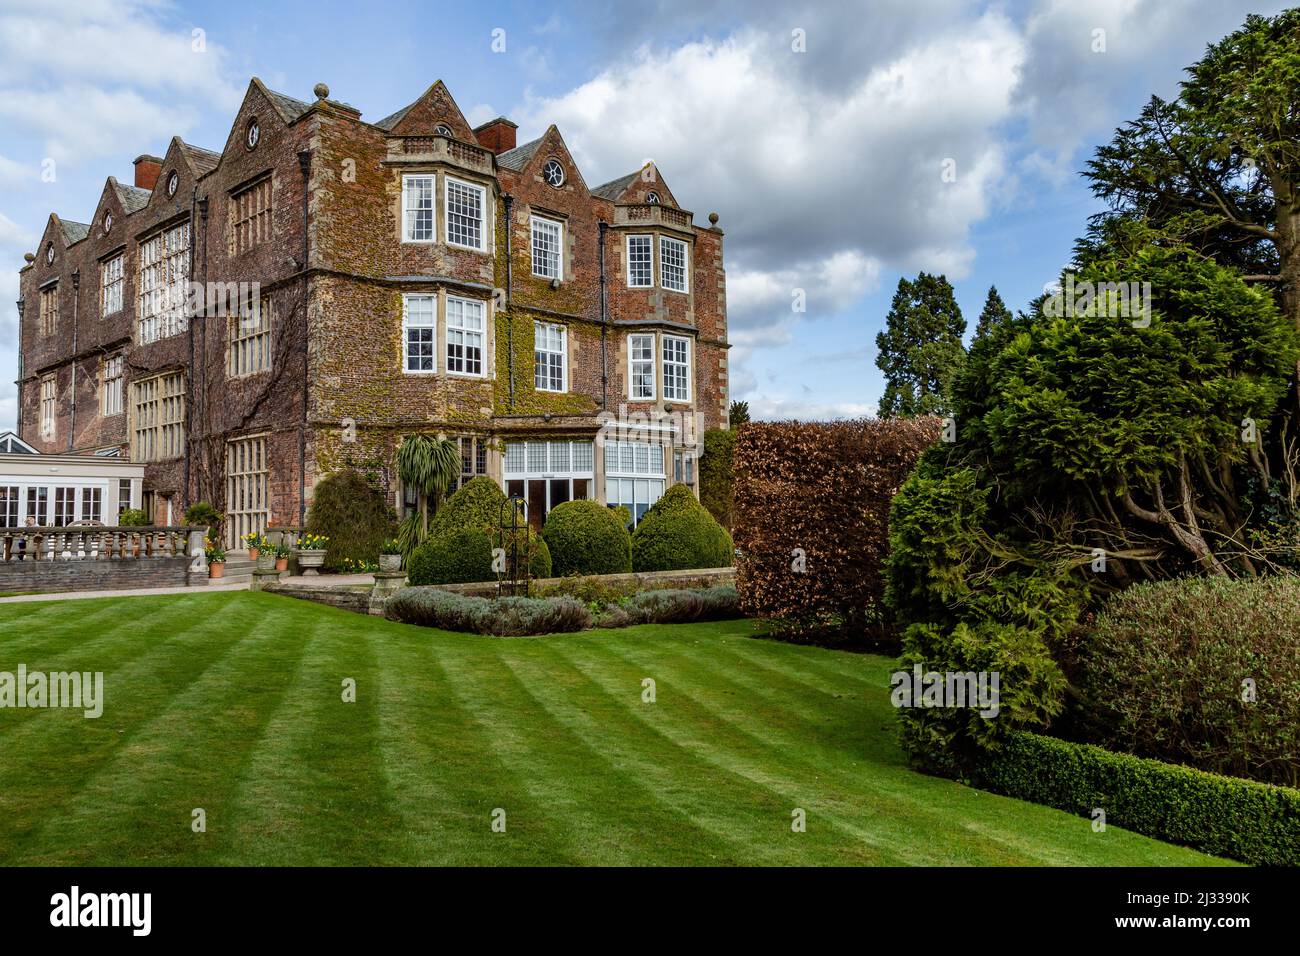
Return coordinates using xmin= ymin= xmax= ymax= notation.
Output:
xmin=733 ymin=418 xmax=941 ymax=640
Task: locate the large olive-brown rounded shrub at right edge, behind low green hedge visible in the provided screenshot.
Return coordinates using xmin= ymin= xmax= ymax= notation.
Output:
xmin=1079 ymin=575 xmax=1300 ymax=787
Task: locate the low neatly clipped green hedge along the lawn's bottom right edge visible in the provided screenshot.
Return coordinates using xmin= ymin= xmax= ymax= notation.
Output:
xmin=978 ymin=731 xmax=1300 ymax=866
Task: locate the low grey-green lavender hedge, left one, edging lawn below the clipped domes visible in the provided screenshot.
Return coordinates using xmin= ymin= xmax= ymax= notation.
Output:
xmin=384 ymin=588 xmax=592 ymax=637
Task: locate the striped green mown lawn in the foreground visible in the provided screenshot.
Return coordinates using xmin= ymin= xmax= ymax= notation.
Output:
xmin=0 ymin=592 xmax=1218 ymax=865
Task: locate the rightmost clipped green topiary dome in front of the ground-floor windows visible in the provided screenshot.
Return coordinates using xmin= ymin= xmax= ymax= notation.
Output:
xmin=632 ymin=484 xmax=735 ymax=571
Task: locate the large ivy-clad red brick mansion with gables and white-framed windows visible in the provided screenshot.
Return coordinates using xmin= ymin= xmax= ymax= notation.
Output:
xmin=15 ymin=78 xmax=728 ymax=546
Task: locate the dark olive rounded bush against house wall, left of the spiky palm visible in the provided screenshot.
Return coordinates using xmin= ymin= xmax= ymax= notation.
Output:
xmin=307 ymin=468 xmax=397 ymax=571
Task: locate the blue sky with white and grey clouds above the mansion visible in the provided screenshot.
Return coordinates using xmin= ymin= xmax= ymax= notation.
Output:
xmin=0 ymin=0 xmax=1282 ymax=428
